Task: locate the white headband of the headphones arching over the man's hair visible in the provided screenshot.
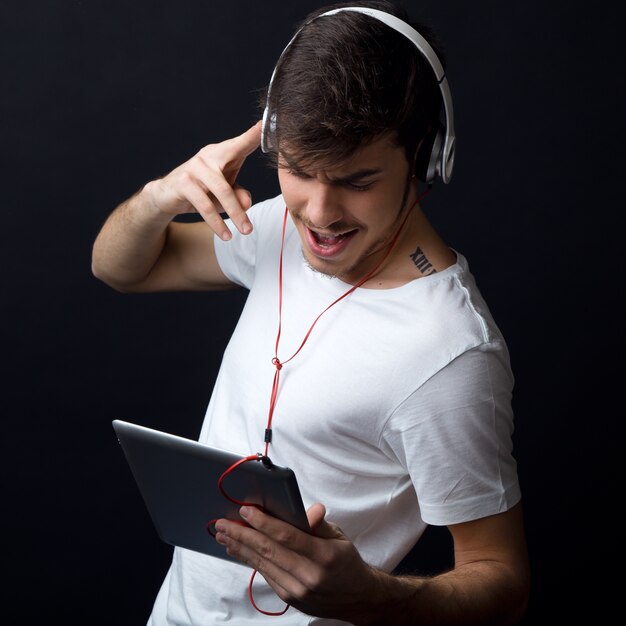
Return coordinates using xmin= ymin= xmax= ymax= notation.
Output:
xmin=261 ymin=7 xmax=456 ymax=183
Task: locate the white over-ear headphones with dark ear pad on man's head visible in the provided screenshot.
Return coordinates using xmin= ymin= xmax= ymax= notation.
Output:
xmin=261 ymin=7 xmax=456 ymax=184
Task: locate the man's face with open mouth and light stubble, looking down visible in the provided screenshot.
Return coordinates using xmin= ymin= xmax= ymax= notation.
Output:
xmin=278 ymin=137 xmax=414 ymax=284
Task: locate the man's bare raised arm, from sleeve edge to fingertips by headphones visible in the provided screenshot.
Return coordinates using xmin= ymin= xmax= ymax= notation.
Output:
xmin=92 ymin=122 xmax=261 ymax=292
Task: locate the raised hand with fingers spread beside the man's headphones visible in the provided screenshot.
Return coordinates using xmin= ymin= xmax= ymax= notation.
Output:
xmin=143 ymin=121 xmax=261 ymax=241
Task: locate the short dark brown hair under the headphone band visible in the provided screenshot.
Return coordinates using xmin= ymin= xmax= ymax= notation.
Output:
xmin=262 ymin=0 xmax=444 ymax=168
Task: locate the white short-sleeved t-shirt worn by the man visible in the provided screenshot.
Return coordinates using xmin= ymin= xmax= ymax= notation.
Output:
xmin=149 ymin=196 xmax=520 ymax=626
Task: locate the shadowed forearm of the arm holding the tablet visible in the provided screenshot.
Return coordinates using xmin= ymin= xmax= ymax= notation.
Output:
xmin=354 ymin=562 xmax=527 ymax=626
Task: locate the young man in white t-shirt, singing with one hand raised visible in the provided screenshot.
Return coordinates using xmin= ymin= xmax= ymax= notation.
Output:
xmin=93 ymin=2 xmax=529 ymax=626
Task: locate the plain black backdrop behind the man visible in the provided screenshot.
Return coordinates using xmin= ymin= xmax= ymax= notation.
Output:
xmin=0 ymin=0 xmax=624 ymax=626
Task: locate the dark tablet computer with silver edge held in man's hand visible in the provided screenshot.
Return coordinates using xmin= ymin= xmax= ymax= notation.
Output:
xmin=113 ymin=420 xmax=310 ymax=563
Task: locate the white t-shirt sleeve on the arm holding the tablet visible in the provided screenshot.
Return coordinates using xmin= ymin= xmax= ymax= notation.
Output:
xmin=382 ymin=343 xmax=521 ymax=525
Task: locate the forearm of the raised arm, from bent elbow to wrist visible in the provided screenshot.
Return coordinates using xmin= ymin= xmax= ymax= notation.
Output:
xmin=92 ymin=183 xmax=172 ymax=291
